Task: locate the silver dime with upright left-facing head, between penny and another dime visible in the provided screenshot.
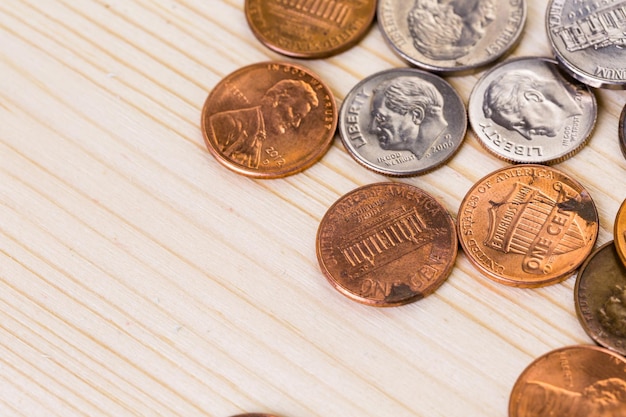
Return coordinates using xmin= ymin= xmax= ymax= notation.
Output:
xmin=339 ymin=68 xmax=467 ymax=176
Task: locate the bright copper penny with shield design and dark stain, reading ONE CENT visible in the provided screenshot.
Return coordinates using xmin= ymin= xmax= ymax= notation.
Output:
xmin=457 ymin=165 xmax=599 ymax=287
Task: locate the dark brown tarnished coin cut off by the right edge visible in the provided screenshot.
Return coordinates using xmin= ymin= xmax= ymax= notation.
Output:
xmin=574 ymin=242 xmax=626 ymax=355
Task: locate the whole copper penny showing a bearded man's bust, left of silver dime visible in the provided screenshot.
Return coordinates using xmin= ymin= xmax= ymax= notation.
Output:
xmin=201 ymin=62 xmax=338 ymax=178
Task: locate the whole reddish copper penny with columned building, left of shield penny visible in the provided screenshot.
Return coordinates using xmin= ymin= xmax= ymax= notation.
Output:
xmin=316 ymin=182 xmax=458 ymax=307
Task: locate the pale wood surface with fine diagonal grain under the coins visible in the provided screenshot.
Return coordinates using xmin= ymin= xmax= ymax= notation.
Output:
xmin=0 ymin=0 xmax=626 ymax=417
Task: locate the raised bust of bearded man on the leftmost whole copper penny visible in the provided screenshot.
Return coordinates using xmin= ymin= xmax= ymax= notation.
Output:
xmin=209 ymin=79 xmax=319 ymax=168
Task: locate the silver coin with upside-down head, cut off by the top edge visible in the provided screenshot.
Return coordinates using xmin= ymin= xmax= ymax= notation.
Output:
xmin=377 ymin=0 xmax=526 ymax=72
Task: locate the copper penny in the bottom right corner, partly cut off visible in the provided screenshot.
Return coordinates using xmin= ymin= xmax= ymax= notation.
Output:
xmin=509 ymin=345 xmax=626 ymax=417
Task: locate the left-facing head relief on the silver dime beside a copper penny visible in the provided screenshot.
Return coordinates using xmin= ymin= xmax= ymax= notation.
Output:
xmin=369 ymin=76 xmax=448 ymax=159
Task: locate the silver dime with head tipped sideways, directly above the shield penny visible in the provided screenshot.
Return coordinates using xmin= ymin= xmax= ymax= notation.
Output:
xmin=468 ymin=58 xmax=597 ymax=164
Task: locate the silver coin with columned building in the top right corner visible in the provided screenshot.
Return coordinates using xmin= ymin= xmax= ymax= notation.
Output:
xmin=546 ymin=0 xmax=626 ymax=89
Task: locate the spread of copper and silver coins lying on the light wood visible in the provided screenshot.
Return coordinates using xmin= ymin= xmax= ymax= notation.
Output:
xmin=201 ymin=0 xmax=626 ymax=417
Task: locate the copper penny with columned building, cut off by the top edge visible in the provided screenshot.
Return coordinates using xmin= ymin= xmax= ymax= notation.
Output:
xmin=244 ymin=0 xmax=376 ymax=58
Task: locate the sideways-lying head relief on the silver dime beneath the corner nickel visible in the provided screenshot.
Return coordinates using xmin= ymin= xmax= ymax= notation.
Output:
xmin=483 ymin=69 xmax=582 ymax=140
